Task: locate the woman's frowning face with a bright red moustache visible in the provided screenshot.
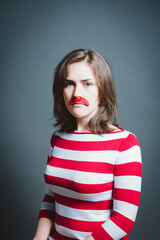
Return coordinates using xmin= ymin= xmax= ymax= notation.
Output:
xmin=63 ymin=62 xmax=99 ymax=122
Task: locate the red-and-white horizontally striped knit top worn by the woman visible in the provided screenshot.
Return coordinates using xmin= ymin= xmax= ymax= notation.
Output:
xmin=39 ymin=128 xmax=142 ymax=240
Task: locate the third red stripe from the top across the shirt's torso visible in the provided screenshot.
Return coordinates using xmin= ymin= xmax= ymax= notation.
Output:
xmin=45 ymin=174 xmax=113 ymax=193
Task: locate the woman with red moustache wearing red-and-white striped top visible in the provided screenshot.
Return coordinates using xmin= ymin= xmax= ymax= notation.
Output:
xmin=34 ymin=49 xmax=142 ymax=240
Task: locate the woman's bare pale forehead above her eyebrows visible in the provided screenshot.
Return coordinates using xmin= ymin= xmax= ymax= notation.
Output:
xmin=67 ymin=62 xmax=95 ymax=80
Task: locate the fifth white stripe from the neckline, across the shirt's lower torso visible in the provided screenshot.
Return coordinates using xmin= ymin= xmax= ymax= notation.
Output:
xmin=56 ymin=202 xmax=112 ymax=222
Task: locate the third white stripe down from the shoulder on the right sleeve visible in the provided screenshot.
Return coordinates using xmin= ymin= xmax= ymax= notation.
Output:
xmin=113 ymin=199 xmax=138 ymax=222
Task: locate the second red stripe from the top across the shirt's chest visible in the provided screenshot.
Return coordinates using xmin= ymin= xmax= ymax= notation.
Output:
xmin=48 ymin=157 xmax=114 ymax=173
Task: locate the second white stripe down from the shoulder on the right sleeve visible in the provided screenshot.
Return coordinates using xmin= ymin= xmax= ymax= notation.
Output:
xmin=114 ymin=176 xmax=142 ymax=192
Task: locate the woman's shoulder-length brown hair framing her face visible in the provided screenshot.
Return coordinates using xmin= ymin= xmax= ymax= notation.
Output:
xmin=53 ymin=49 xmax=118 ymax=134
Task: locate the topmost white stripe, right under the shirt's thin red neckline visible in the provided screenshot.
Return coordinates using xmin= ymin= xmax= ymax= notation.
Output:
xmin=55 ymin=131 xmax=129 ymax=142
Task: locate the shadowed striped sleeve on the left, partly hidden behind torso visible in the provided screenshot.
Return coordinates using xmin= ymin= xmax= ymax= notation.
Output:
xmin=38 ymin=134 xmax=55 ymax=220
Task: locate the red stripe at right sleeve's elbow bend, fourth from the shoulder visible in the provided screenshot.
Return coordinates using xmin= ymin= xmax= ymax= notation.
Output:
xmin=110 ymin=212 xmax=134 ymax=233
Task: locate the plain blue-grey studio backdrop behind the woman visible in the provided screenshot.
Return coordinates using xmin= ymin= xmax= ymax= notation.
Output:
xmin=0 ymin=0 xmax=160 ymax=240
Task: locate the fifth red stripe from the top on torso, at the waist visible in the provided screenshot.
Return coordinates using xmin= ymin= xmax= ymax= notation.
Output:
xmin=55 ymin=213 xmax=104 ymax=232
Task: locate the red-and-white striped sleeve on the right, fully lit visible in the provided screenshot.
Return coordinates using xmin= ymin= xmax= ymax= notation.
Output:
xmin=92 ymin=134 xmax=142 ymax=240
